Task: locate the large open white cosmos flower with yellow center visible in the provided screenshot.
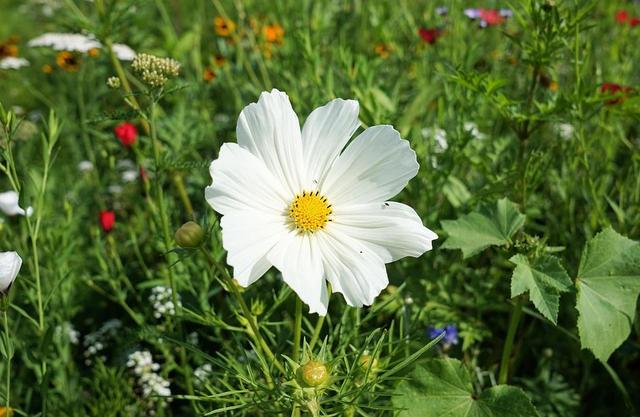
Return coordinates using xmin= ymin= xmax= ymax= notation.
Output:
xmin=205 ymin=90 xmax=437 ymax=315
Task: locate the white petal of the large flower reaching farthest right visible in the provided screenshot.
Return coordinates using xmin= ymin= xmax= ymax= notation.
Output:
xmin=331 ymin=201 xmax=438 ymax=263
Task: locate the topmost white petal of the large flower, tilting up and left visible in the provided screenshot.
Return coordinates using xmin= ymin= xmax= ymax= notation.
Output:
xmin=236 ymin=89 xmax=304 ymax=196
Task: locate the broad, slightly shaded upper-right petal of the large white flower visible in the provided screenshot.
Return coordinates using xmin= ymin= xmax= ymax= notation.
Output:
xmin=322 ymin=125 xmax=418 ymax=206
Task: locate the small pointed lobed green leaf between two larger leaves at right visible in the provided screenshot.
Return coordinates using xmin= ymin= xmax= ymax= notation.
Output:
xmin=509 ymin=254 xmax=572 ymax=324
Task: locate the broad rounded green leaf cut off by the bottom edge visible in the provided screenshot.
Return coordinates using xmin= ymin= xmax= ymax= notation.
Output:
xmin=393 ymin=359 xmax=539 ymax=417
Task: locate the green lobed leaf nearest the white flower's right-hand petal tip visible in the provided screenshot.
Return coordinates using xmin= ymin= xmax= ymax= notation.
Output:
xmin=442 ymin=198 xmax=525 ymax=258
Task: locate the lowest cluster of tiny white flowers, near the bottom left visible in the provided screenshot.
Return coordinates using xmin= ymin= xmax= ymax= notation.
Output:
xmin=127 ymin=350 xmax=171 ymax=415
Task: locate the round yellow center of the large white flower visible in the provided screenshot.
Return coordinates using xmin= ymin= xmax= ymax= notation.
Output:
xmin=289 ymin=191 xmax=333 ymax=232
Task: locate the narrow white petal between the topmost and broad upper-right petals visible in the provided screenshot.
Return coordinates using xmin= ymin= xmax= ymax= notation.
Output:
xmin=302 ymin=98 xmax=360 ymax=189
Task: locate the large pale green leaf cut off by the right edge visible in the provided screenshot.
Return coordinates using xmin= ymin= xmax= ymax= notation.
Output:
xmin=576 ymin=227 xmax=640 ymax=362
